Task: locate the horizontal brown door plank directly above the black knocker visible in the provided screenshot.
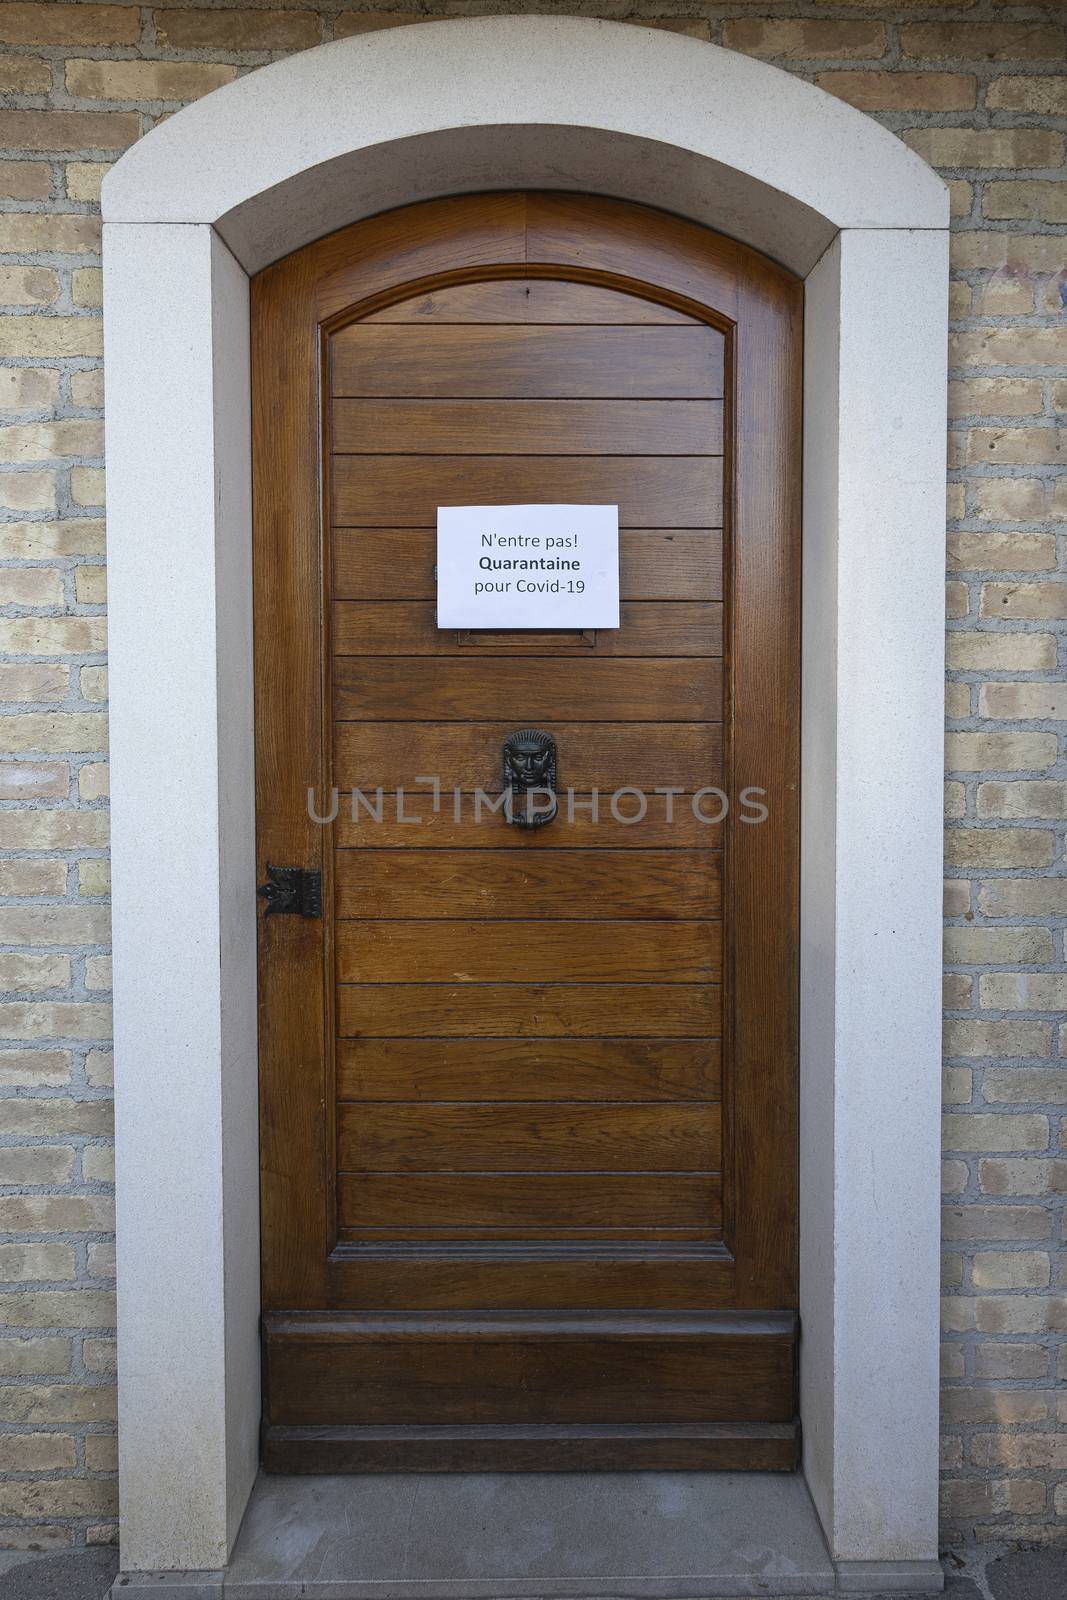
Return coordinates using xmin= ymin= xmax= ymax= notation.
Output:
xmin=333 ymin=656 xmax=723 ymax=725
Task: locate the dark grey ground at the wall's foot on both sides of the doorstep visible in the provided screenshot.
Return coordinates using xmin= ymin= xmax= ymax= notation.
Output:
xmin=0 ymin=1547 xmax=1067 ymax=1600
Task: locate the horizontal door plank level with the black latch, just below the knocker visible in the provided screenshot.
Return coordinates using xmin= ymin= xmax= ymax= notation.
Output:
xmin=334 ymin=850 xmax=721 ymax=921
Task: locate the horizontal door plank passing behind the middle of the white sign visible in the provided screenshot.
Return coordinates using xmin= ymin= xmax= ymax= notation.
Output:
xmin=331 ymin=528 xmax=723 ymax=601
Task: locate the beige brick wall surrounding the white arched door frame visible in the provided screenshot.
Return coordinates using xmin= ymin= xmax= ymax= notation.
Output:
xmin=0 ymin=0 xmax=1067 ymax=1549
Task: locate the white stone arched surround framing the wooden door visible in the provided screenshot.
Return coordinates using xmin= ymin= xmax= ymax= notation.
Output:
xmin=102 ymin=16 xmax=947 ymax=1581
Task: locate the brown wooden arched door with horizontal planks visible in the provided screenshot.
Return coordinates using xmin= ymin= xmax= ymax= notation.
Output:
xmin=253 ymin=194 xmax=801 ymax=1470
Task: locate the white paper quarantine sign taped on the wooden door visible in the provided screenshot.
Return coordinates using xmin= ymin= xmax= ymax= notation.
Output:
xmin=437 ymin=506 xmax=619 ymax=627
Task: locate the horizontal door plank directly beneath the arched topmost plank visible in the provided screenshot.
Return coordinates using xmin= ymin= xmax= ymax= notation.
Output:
xmin=330 ymin=322 xmax=723 ymax=400
